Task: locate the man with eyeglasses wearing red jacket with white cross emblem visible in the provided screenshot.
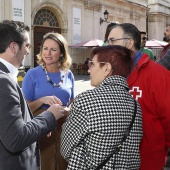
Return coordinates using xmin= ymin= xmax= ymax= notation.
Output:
xmin=108 ymin=23 xmax=170 ymax=170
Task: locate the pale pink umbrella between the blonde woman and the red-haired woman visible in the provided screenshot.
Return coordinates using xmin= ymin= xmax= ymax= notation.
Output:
xmin=70 ymin=39 xmax=103 ymax=47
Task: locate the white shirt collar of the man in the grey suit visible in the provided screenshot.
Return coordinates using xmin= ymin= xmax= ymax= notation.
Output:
xmin=0 ymin=58 xmax=19 ymax=81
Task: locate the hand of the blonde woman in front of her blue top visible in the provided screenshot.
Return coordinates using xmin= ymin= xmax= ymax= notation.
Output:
xmin=41 ymin=96 xmax=62 ymax=106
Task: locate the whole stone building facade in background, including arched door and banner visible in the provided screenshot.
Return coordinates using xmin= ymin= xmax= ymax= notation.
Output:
xmin=0 ymin=0 xmax=170 ymax=67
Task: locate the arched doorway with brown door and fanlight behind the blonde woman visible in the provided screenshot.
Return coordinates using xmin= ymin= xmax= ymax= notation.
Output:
xmin=34 ymin=9 xmax=61 ymax=67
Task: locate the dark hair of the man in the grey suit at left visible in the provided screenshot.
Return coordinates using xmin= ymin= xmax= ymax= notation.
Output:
xmin=0 ymin=20 xmax=30 ymax=53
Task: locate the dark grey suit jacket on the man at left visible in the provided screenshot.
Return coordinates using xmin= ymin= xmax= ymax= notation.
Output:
xmin=0 ymin=62 xmax=56 ymax=170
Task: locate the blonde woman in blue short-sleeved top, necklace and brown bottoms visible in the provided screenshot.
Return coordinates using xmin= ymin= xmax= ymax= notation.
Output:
xmin=22 ymin=33 xmax=74 ymax=170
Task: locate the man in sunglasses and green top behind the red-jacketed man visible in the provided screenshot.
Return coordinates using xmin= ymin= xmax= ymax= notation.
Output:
xmin=140 ymin=31 xmax=155 ymax=61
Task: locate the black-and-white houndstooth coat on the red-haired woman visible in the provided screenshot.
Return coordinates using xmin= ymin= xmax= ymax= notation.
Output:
xmin=61 ymin=76 xmax=142 ymax=170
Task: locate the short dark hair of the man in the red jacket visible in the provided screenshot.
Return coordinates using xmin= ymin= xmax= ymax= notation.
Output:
xmin=115 ymin=23 xmax=141 ymax=50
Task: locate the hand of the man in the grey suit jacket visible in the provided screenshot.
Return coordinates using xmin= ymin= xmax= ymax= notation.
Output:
xmin=47 ymin=104 xmax=64 ymax=120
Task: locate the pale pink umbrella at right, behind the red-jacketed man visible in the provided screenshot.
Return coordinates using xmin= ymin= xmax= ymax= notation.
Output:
xmin=145 ymin=39 xmax=168 ymax=48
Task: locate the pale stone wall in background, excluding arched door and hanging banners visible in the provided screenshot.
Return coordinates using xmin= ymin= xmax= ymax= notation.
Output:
xmin=0 ymin=0 xmax=170 ymax=66
